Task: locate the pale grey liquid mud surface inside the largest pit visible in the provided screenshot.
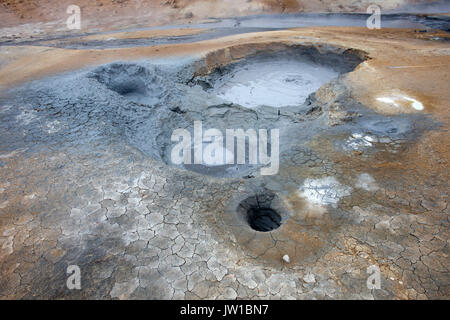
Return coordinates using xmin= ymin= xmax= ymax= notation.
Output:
xmin=204 ymin=57 xmax=338 ymax=108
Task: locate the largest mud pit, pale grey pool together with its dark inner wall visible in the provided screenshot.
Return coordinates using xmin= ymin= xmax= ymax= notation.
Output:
xmin=193 ymin=47 xmax=361 ymax=108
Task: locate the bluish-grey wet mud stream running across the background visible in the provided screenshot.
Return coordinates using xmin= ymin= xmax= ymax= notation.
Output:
xmin=0 ymin=13 xmax=450 ymax=49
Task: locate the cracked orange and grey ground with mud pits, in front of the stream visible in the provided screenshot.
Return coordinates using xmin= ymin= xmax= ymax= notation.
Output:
xmin=0 ymin=4 xmax=450 ymax=299
